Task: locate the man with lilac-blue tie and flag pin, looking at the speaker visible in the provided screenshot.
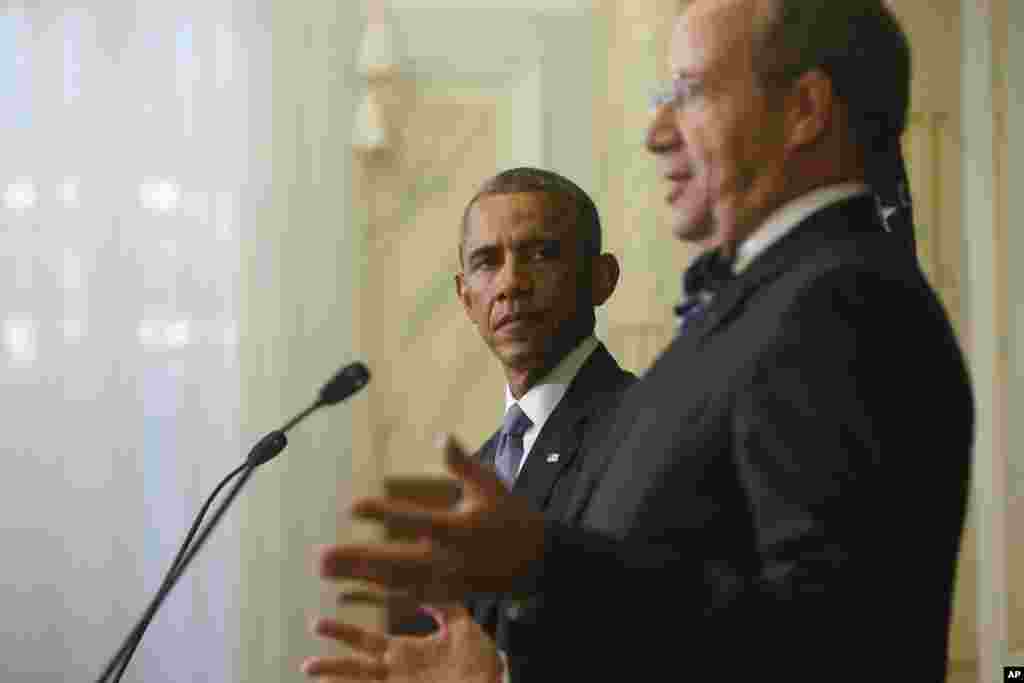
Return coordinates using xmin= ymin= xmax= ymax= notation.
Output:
xmin=303 ymin=168 xmax=636 ymax=671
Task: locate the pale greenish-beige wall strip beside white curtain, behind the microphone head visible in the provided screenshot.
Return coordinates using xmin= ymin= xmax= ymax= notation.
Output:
xmin=238 ymin=0 xmax=365 ymax=683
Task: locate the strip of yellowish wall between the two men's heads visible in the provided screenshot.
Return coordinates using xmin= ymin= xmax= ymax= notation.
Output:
xmin=594 ymin=0 xmax=693 ymax=372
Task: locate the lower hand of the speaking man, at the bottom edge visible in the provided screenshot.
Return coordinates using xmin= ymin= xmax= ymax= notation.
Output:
xmin=302 ymin=604 xmax=503 ymax=683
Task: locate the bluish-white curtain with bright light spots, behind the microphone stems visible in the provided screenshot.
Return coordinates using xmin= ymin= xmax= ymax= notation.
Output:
xmin=0 ymin=0 xmax=273 ymax=683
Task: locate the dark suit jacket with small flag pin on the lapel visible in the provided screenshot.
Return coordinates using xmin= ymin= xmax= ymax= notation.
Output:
xmin=469 ymin=344 xmax=636 ymax=674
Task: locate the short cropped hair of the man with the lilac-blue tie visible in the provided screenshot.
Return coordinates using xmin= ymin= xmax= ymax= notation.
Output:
xmin=459 ymin=166 xmax=601 ymax=266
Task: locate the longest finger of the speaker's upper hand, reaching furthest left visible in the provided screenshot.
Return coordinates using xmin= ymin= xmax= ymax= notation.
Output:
xmin=315 ymin=543 xmax=436 ymax=590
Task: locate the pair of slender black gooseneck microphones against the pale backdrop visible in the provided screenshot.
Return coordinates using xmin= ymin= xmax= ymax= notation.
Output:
xmin=96 ymin=362 xmax=370 ymax=683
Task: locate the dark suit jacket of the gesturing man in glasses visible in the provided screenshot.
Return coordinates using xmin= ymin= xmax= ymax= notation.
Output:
xmin=516 ymin=198 xmax=974 ymax=683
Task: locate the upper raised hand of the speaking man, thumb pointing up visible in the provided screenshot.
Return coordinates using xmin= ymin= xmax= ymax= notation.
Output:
xmin=316 ymin=437 xmax=545 ymax=602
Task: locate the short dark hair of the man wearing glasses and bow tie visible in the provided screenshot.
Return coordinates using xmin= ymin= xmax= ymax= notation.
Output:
xmin=754 ymin=0 xmax=910 ymax=148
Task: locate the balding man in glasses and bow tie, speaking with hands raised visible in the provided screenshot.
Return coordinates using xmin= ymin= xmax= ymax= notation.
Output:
xmin=305 ymin=0 xmax=974 ymax=681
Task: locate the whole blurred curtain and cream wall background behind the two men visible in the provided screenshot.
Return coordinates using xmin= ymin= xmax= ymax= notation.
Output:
xmin=0 ymin=0 xmax=1024 ymax=683
